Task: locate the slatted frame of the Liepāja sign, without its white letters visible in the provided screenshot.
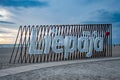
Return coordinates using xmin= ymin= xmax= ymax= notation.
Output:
xmin=9 ymin=24 xmax=112 ymax=63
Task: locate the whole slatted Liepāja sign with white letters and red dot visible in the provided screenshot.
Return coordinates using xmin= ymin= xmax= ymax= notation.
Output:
xmin=10 ymin=24 xmax=112 ymax=63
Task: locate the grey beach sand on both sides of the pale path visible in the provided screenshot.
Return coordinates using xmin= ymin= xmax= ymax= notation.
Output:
xmin=0 ymin=46 xmax=120 ymax=80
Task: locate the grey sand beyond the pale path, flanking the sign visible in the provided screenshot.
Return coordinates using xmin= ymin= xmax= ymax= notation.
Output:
xmin=0 ymin=46 xmax=120 ymax=69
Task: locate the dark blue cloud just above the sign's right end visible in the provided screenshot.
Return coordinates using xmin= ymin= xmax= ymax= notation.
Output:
xmin=83 ymin=9 xmax=120 ymax=24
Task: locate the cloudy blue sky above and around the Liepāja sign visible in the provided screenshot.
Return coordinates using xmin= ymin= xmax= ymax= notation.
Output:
xmin=0 ymin=0 xmax=120 ymax=44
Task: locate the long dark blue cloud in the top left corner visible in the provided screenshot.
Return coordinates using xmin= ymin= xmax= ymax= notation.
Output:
xmin=0 ymin=0 xmax=48 ymax=8
